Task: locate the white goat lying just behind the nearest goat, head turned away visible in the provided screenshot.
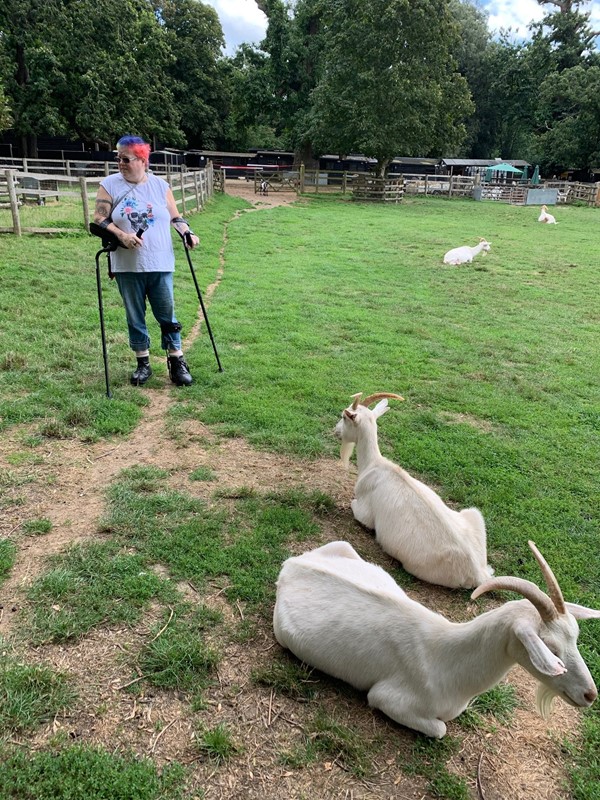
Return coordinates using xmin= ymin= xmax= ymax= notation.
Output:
xmin=335 ymin=393 xmax=493 ymax=589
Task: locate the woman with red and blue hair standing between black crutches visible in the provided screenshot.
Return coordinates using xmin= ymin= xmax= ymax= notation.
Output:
xmin=94 ymin=136 xmax=200 ymax=386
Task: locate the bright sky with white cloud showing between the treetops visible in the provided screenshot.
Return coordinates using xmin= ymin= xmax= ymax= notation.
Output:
xmin=203 ymin=0 xmax=600 ymax=55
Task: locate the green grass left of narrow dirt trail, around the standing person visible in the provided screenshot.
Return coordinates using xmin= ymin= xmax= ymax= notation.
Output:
xmin=0 ymin=197 xmax=246 ymax=440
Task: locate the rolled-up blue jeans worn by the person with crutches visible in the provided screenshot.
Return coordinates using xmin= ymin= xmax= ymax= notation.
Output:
xmin=115 ymin=272 xmax=181 ymax=352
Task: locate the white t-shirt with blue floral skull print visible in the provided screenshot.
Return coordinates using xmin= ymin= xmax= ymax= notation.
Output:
xmin=100 ymin=172 xmax=175 ymax=272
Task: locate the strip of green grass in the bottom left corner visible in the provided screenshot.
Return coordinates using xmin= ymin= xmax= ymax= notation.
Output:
xmin=0 ymin=745 xmax=188 ymax=800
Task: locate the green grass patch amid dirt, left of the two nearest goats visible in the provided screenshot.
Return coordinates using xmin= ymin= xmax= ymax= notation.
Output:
xmin=102 ymin=467 xmax=331 ymax=616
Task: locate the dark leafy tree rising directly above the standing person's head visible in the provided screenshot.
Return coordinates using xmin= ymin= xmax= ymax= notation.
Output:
xmin=53 ymin=0 xmax=185 ymax=147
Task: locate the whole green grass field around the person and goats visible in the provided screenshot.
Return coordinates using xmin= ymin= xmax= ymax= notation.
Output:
xmin=0 ymin=191 xmax=600 ymax=800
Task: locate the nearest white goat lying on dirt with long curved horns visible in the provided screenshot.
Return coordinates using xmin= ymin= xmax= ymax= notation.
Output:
xmin=273 ymin=542 xmax=600 ymax=738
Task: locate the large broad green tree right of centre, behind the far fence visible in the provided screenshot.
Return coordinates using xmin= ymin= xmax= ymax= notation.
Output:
xmin=309 ymin=0 xmax=473 ymax=174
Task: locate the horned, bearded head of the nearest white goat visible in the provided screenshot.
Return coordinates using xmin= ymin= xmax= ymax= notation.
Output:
xmin=471 ymin=541 xmax=600 ymax=716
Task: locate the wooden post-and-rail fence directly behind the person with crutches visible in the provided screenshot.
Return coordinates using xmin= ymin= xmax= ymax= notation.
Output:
xmin=0 ymin=162 xmax=214 ymax=236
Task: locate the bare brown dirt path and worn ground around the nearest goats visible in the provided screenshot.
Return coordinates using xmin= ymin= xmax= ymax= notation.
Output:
xmin=0 ymin=181 xmax=579 ymax=800
